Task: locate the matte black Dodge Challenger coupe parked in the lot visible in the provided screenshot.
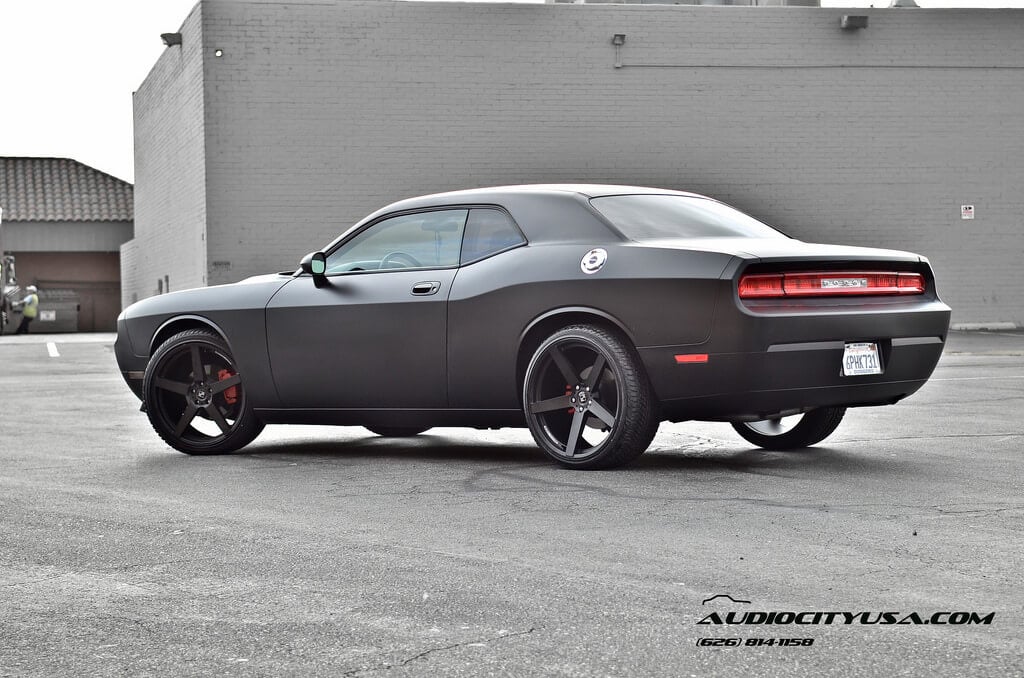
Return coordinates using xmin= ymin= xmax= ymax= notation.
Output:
xmin=115 ymin=185 xmax=949 ymax=469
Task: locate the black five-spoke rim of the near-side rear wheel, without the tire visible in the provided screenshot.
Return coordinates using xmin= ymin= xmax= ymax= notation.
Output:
xmin=526 ymin=339 xmax=622 ymax=461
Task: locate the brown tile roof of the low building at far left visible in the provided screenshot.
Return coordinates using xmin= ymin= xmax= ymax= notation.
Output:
xmin=0 ymin=158 xmax=134 ymax=221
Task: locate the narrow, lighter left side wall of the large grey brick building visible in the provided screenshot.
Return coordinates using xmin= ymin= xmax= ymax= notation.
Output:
xmin=121 ymin=5 xmax=207 ymax=305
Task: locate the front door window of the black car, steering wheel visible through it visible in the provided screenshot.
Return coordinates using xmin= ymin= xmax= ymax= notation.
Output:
xmin=327 ymin=210 xmax=469 ymax=273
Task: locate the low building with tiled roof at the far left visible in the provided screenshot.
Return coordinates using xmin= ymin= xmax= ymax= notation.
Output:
xmin=0 ymin=158 xmax=133 ymax=332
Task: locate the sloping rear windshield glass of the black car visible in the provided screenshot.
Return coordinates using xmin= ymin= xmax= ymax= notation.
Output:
xmin=590 ymin=195 xmax=786 ymax=242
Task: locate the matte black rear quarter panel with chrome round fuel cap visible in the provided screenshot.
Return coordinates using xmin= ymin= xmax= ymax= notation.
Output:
xmin=449 ymin=242 xmax=733 ymax=409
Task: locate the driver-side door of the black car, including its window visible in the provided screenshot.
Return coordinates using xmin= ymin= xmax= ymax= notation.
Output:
xmin=266 ymin=209 xmax=468 ymax=410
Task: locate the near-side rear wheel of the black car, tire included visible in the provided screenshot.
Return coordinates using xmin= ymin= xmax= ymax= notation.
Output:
xmin=522 ymin=325 xmax=659 ymax=469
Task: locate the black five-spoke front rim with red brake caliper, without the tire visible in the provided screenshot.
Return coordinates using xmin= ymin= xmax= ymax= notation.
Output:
xmin=147 ymin=342 xmax=245 ymax=447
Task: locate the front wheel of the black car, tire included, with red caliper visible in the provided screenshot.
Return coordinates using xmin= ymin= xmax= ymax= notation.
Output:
xmin=142 ymin=330 xmax=263 ymax=455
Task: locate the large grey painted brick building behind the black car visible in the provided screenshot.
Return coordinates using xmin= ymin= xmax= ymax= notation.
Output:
xmin=128 ymin=0 xmax=1024 ymax=324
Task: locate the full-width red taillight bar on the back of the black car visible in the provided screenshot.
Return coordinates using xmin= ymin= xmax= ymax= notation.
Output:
xmin=739 ymin=271 xmax=925 ymax=299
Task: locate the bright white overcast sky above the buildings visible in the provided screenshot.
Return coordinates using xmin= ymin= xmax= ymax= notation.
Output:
xmin=0 ymin=0 xmax=1024 ymax=186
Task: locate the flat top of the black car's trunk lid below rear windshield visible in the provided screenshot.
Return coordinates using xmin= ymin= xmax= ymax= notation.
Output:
xmin=644 ymin=238 xmax=922 ymax=261
